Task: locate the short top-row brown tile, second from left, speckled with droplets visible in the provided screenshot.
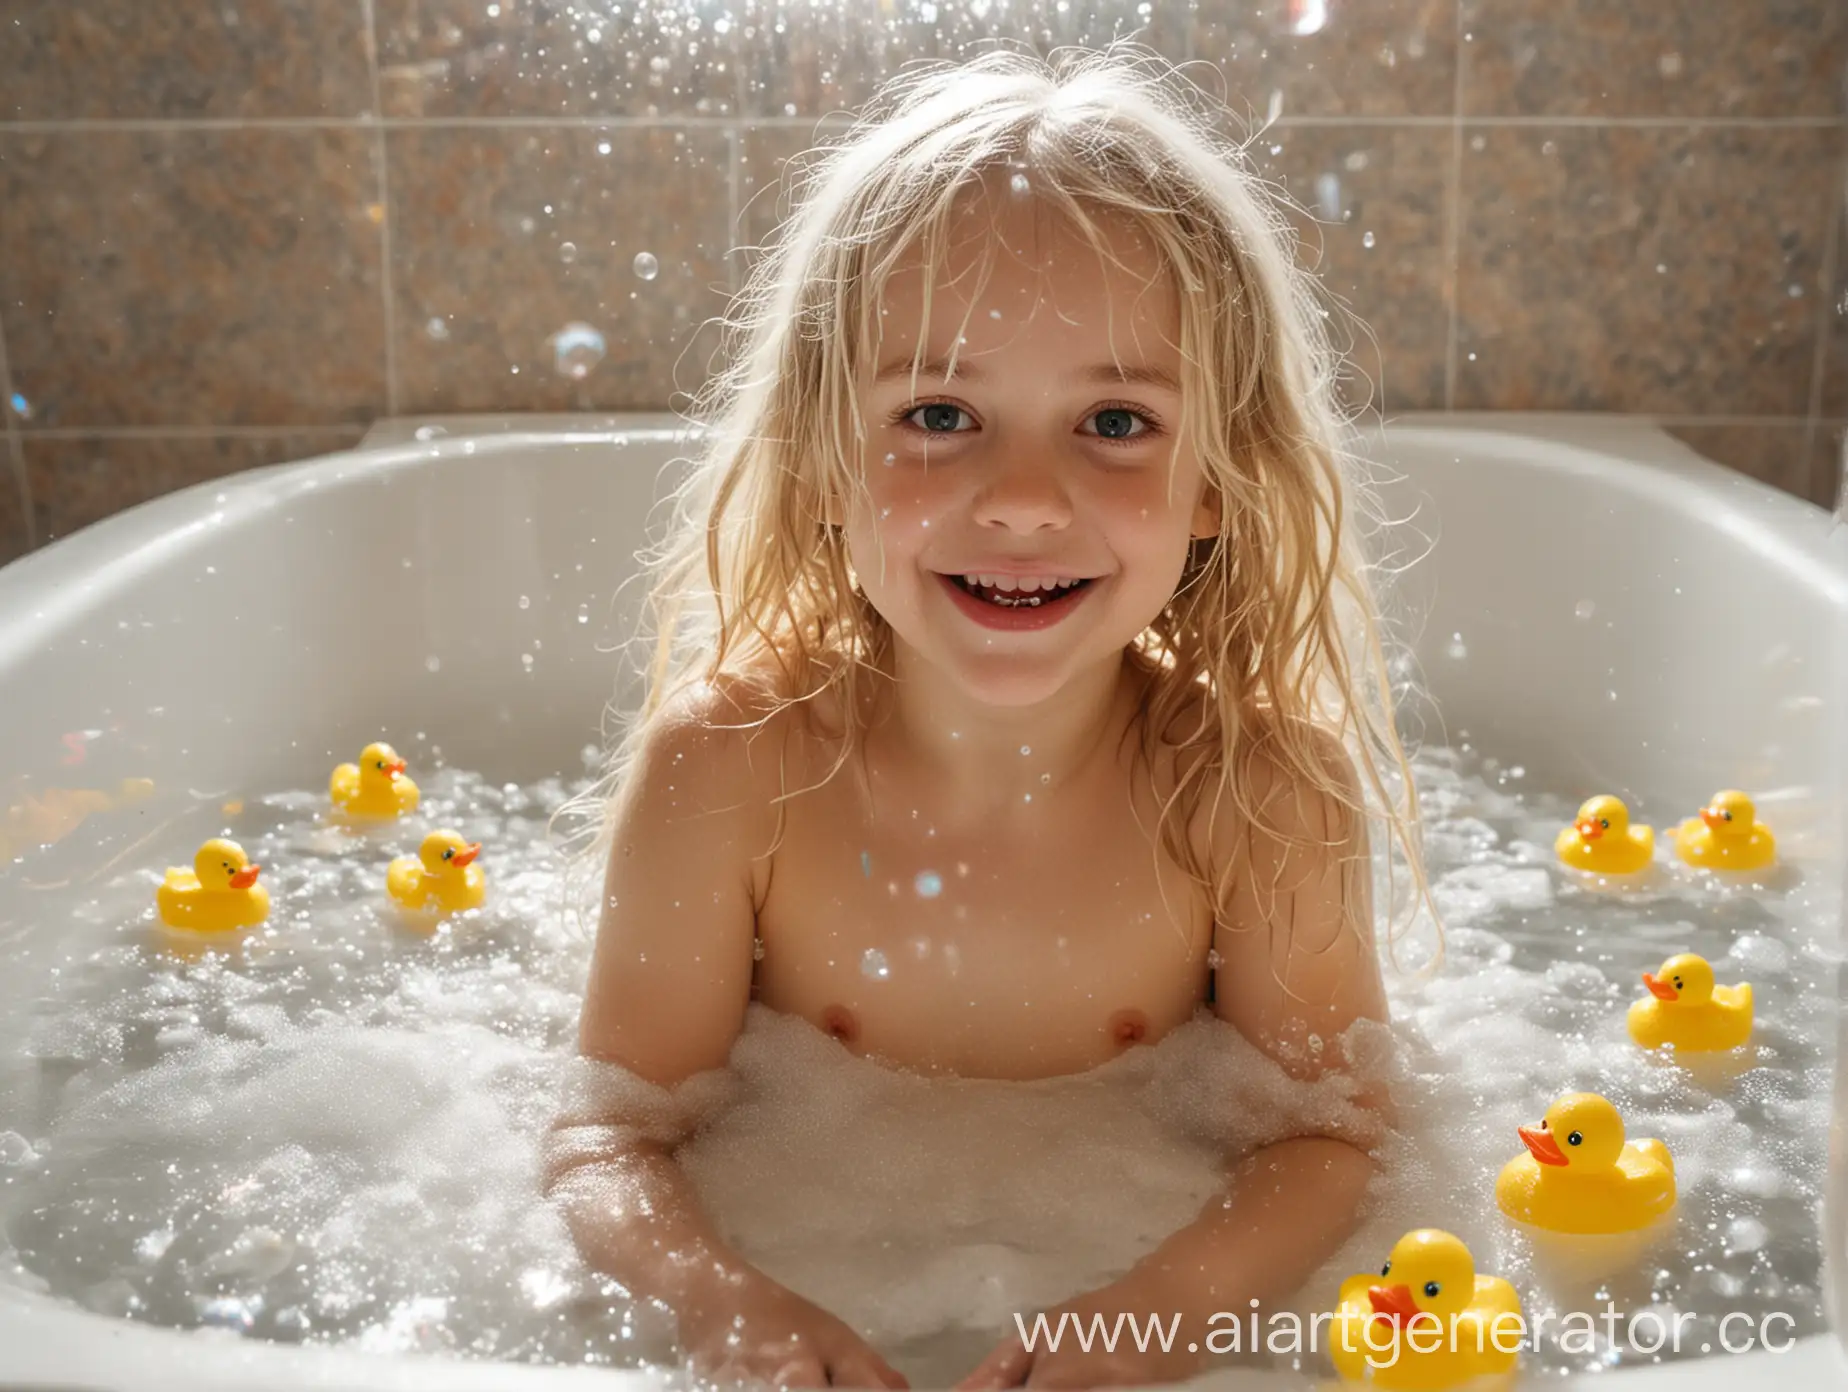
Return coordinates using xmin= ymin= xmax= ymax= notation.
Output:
xmin=375 ymin=0 xmax=739 ymax=116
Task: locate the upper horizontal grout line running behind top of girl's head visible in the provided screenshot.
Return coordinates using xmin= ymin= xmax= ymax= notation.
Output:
xmin=0 ymin=113 xmax=1842 ymax=135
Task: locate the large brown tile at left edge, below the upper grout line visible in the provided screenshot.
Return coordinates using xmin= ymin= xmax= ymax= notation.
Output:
xmin=0 ymin=129 xmax=384 ymax=427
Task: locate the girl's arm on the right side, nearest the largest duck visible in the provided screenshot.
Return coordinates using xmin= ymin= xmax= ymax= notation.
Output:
xmin=959 ymin=739 xmax=1390 ymax=1388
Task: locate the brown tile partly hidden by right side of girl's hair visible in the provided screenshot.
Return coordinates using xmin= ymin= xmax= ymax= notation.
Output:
xmin=1251 ymin=126 xmax=1451 ymax=412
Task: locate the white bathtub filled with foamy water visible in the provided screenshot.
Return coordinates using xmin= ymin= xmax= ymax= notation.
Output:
xmin=0 ymin=418 xmax=1848 ymax=1392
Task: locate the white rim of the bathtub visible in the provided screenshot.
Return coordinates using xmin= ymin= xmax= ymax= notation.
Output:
xmin=0 ymin=414 xmax=1848 ymax=1392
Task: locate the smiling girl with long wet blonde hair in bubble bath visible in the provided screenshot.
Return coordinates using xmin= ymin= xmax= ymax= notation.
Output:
xmin=551 ymin=48 xmax=1416 ymax=1388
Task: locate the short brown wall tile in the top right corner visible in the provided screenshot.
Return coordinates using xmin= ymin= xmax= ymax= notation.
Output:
xmin=1464 ymin=0 xmax=1848 ymax=116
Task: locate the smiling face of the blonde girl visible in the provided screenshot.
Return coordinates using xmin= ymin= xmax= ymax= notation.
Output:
xmin=845 ymin=183 xmax=1218 ymax=706
